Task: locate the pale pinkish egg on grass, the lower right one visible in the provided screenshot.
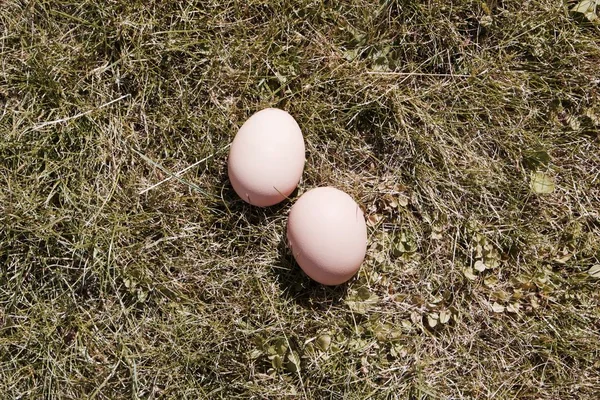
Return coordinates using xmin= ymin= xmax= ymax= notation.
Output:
xmin=287 ymin=187 xmax=367 ymax=285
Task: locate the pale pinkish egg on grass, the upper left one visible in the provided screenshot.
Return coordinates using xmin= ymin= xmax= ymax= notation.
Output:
xmin=228 ymin=108 xmax=305 ymax=207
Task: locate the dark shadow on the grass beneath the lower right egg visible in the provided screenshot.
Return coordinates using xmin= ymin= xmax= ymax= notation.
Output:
xmin=271 ymin=236 xmax=348 ymax=311
